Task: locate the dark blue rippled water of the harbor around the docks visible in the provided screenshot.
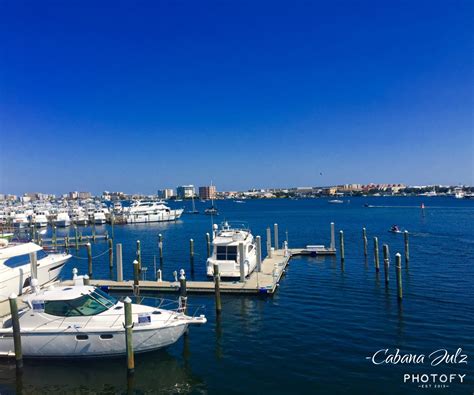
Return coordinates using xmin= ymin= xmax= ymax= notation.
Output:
xmin=0 ymin=197 xmax=474 ymax=394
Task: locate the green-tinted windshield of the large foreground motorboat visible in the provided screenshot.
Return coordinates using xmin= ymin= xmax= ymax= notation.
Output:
xmin=44 ymin=289 xmax=117 ymax=317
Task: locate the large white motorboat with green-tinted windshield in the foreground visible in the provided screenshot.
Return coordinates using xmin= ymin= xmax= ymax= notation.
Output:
xmin=0 ymin=280 xmax=207 ymax=358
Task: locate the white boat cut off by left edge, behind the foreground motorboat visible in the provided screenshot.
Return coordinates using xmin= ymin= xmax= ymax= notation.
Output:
xmin=0 ymin=240 xmax=71 ymax=301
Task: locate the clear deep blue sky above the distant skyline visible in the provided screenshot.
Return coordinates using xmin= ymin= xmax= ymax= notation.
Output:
xmin=0 ymin=0 xmax=474 ymax=193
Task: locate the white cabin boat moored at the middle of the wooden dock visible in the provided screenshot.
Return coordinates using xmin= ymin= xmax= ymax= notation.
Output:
xmin=206 ymin=221 xmax=257 ymax=278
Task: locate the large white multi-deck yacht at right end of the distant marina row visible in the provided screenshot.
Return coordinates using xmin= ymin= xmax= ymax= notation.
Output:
xmin=125 ymin=201 xmax=184 ymax=224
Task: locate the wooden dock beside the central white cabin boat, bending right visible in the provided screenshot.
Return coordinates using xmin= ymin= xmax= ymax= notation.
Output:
xmin=69 ymin=247 xmax=336 ymax=294
